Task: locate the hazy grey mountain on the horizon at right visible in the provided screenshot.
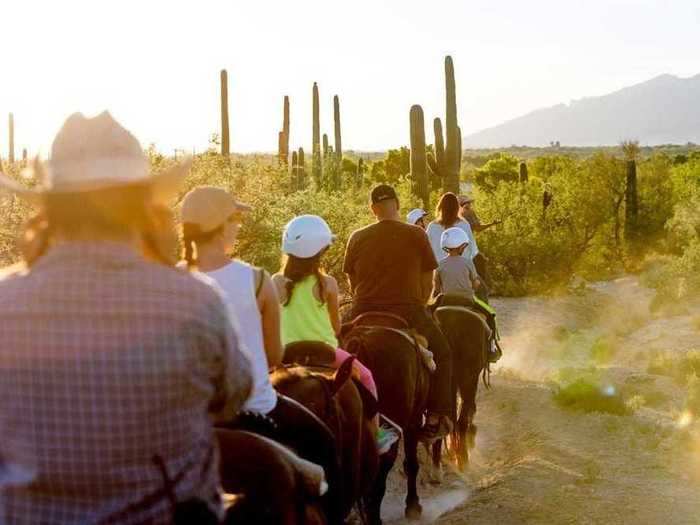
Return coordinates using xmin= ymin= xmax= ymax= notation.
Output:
xmin=463 ymin=75 xmax=700 ymax=148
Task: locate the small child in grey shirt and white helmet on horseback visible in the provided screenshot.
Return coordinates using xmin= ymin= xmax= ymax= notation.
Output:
xmin=433 ymin=228 xmax=502 ymax=363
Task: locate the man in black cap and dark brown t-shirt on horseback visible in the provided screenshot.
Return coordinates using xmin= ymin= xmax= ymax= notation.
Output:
xmin=343 ymin=184 xmax=452 ymax=439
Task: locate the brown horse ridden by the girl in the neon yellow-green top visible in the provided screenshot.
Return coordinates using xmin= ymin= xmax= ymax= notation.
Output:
xmin=270 ymin=350 xmax=379 ymax=517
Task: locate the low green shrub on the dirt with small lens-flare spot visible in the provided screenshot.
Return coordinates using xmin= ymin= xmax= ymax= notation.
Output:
xmin=554 ymin=379 xmax=630 ymax=416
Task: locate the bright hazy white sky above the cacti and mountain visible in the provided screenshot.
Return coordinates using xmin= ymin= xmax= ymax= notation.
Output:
xmin=0 ymin=0 xmax=700 ymax=157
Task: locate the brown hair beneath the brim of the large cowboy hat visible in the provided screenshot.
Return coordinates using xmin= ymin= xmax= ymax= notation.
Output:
xmin=19 ymin=184 xmax=171 ymax=266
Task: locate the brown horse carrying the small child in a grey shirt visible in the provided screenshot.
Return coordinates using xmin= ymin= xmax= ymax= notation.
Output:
xmin=432 ymin=302 xmax=491 ymax=474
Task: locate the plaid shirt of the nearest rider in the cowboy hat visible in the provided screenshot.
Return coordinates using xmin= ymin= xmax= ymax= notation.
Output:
xmin=0 ymin=242 xmax=250 ymax=525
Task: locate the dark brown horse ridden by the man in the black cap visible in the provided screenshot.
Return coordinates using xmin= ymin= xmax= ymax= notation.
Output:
xmin=341 ymin=312 xmax=430 ymax=525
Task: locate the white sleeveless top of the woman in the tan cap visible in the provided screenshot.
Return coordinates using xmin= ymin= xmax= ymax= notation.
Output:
xmin=206 ymin=261 xmax=277 ymax=414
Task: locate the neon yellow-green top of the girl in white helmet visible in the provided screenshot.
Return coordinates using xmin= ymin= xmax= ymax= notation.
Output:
xmin=282 ymin=275 xmax=338 ymax=348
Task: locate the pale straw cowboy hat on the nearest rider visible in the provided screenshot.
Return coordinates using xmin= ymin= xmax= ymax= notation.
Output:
xmin=0 ymin=111 xmax=191 ymax=202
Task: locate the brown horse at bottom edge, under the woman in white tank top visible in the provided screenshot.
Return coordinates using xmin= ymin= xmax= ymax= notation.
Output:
xmin=216 ymin=429 xmax=326 ymax=525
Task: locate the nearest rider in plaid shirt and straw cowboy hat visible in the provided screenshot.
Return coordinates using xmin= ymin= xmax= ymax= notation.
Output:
xmin=0 ymin=112 xmax=252 ymax=525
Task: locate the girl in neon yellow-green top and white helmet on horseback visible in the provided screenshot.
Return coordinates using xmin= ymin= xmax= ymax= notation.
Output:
xmin=272 ymin=215 xmax=398 ymax=454
